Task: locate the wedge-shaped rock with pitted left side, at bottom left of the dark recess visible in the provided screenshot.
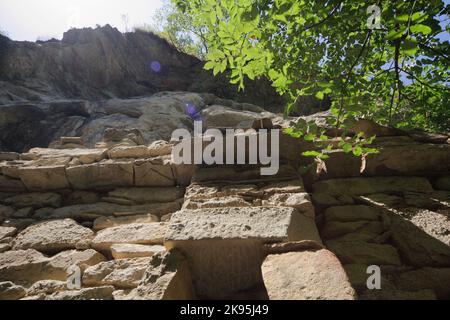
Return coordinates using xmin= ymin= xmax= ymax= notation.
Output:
xmin=129 ymin=250 xmax=196 ymax=300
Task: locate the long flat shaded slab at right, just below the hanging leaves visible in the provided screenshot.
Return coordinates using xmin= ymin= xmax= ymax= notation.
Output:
xmin=313 ymin=177 xmax=433 ymax=195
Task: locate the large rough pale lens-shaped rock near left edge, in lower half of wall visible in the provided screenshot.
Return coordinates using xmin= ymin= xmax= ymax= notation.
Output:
xmin=13 ymin=219 xmax=93 ymax=253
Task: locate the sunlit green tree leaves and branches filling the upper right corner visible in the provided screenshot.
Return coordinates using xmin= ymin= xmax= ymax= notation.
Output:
xmin=174 ymin=0 xmax=450 ymax=132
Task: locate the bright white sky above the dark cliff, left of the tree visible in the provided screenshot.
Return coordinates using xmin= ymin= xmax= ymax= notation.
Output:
xmin=0 ymin=0 xmax=162 ymax=41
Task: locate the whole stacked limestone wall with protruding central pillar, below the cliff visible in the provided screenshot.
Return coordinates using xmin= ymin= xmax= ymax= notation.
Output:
xmin=0 ymin=117 xmax=450 ymax=300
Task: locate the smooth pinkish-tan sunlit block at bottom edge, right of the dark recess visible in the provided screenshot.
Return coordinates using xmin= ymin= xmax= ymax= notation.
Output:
xmin=262 ymin=249 xmax=356 ymax=300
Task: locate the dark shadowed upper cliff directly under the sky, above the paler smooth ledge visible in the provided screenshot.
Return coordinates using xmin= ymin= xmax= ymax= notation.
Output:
xmin=0 ymin=25 xmax=282 ymax=110
